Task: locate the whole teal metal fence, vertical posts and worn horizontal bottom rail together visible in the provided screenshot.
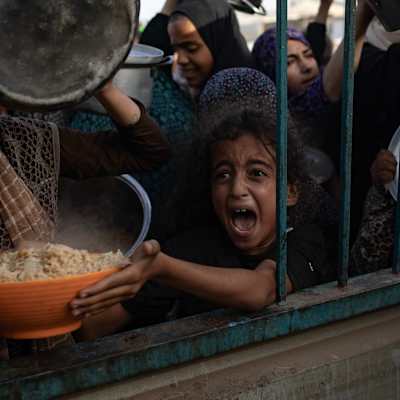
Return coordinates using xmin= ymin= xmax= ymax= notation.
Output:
xmin=0 ymin=0 xmax=400 ymax=400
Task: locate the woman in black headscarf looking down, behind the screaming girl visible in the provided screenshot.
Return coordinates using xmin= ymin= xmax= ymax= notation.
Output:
xmin=120 ymin=0 xmax=253 ymax=238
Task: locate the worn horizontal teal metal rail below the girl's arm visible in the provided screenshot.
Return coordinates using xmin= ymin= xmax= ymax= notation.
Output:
xmin=0 ymin=269 xmax=400 ymax=400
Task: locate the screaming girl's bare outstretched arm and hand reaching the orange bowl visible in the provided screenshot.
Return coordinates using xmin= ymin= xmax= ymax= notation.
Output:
xmin=71 ymin=241 xmax=293 ymax=316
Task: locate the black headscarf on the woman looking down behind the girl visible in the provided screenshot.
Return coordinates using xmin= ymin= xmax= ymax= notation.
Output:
xmin=172 ymin=0 xmax=253 ymax=73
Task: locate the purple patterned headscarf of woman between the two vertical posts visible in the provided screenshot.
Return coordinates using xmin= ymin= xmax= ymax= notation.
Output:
xmin=252 ymin=27 xmax=310 ymax=82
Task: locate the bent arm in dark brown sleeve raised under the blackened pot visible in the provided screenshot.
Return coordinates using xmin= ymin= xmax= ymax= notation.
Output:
xmin=60 ymin=83 xmax=170 ymax=179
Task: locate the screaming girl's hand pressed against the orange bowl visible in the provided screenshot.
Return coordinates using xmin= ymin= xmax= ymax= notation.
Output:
xmin=70 ymin=240 xmax=160 ymax=317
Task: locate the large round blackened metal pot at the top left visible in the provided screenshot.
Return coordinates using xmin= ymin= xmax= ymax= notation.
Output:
xmin=0 ymin=0 xmax=140 ymax=111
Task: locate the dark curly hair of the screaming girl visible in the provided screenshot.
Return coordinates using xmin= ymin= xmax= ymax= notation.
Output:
xmin=160 ymin=107 xmax=303 ymax=239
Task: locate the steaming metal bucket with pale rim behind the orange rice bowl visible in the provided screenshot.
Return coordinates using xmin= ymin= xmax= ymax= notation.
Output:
xmin=54 ymin=175 xmax=151 ymax=256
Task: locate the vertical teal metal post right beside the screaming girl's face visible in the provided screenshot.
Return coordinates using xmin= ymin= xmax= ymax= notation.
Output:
xmin=276 ymin=0 xmax=288 ymax=302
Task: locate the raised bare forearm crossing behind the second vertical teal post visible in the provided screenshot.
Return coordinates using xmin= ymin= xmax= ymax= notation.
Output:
xmin=323 ymin=0 xmax=374 ymax=102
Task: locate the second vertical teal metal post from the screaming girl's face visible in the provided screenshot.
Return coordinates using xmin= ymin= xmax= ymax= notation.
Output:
xmin=339 ymin=0 xmax=355 ymax=287
